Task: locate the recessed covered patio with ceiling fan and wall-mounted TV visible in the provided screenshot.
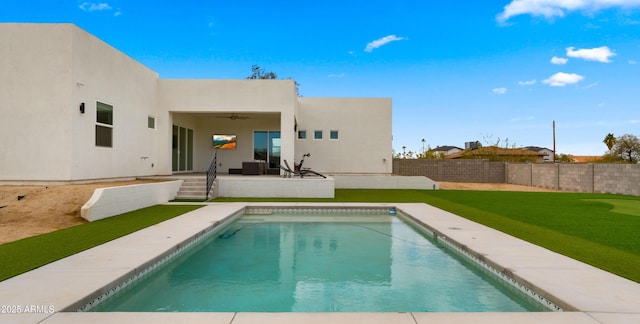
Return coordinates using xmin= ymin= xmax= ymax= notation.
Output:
xmin=171 ymin=112 xmax=294 ymax=175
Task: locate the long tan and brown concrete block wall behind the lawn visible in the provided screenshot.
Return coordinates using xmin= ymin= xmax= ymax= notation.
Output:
xmin=393 ymin=159 xmax=640 ymax=196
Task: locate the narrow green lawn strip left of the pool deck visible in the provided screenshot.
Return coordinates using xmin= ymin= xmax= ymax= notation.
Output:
xmin=0 ymin=205 xmax=202 ymax=281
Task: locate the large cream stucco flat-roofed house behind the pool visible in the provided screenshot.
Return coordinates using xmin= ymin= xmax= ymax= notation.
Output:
xmin=0 ymin=23 xmax=392 ymax=181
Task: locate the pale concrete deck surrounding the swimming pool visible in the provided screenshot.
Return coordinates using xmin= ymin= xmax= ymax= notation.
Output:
xmin=0 ymin=203 xmax=640 ymax=324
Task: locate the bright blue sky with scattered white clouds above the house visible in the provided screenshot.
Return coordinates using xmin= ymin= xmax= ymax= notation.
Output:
xmin=0 ymin=0 xmax=640 ymax=155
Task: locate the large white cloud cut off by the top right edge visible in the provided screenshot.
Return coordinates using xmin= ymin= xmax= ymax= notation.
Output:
xmin=496 ymin=0 xmax=640 ymax=23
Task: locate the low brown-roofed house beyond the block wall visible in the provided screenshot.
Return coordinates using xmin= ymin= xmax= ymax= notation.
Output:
xmin=445 ymin=146 xmax=544 ymax=162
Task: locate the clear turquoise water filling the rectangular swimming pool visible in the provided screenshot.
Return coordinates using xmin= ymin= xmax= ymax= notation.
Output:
xmin=91 ymin=212 xmax=546 ymax=312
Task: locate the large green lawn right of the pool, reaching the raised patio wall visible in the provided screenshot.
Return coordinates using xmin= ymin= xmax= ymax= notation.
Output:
xmin=214 ymin=189 xmax=640 ymax=282
